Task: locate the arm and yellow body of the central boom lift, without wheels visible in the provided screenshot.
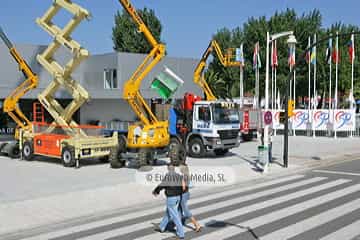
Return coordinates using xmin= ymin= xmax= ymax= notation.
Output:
xmin=119 ymin=0 xmax=170 ymax=149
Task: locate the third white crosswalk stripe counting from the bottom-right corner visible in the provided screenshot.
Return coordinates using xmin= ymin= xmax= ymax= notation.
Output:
xmin=193 ymin=181 xmax=360 ymax=240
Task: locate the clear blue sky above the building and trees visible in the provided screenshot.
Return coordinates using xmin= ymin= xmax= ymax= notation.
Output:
xmin=0 ymin=0 xmax=360 ymax=58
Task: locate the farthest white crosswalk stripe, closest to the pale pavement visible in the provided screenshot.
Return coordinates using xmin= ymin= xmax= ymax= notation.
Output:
xmin=22 ymin=175 xmax=304 ymax=240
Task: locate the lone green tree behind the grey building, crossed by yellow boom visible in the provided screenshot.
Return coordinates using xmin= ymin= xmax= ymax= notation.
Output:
xmin=112 ymin=8 xmax=162 ymax=53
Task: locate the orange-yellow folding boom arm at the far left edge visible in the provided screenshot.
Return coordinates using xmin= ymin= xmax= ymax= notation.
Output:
xmin=0 ymin=28 xmax=38 ymax=139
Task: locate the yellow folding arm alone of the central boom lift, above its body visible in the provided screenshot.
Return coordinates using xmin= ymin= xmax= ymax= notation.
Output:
xmin=119 ymin=0 xmax=165 ymax=125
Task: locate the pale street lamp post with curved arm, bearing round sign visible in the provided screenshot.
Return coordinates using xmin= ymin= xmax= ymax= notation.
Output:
xmin=264 ymin=31 xmax=295 ymax=152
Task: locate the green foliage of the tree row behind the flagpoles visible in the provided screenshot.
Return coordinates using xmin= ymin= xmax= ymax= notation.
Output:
xmin=209 ymin=9 xmax=360 ymax=98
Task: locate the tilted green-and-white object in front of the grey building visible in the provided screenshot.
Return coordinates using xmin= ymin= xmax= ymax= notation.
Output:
xmin=150 ymin=67 xmax=184 ymax=99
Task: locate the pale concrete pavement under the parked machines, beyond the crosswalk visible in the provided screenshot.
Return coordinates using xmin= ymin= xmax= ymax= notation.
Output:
xmin=0 ymin=136 xmax=360 ymax=236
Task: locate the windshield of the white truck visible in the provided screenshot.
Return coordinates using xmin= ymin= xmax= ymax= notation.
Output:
xmin=212 ymin=104 xmax=240 ymax=124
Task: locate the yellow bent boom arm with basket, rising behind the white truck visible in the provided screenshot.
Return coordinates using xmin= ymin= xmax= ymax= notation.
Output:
xmin=194 ymin=40 xmax=240 ymax=101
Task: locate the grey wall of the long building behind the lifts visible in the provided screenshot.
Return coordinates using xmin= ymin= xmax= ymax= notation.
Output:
xmin=0 ymin=42 xmax=202 ymax=124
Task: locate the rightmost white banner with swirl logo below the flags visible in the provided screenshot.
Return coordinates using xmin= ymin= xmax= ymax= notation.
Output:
xmin=334 ymin=109 xmax=355 ymax=131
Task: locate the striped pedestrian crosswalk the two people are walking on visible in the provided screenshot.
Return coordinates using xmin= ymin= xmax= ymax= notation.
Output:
xmin=21 ymin=175 xmax=360 ymax=240
